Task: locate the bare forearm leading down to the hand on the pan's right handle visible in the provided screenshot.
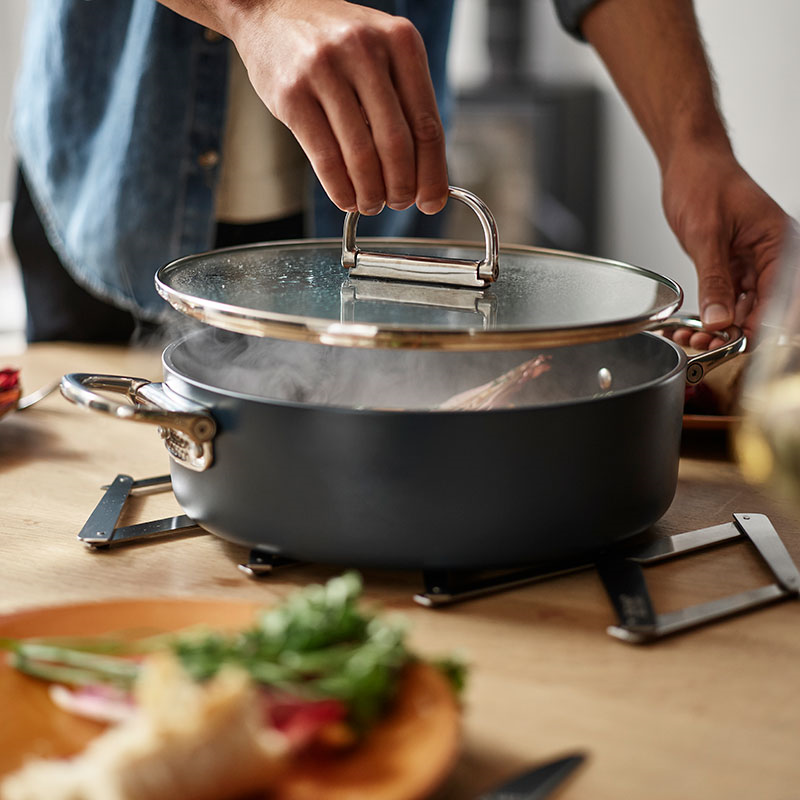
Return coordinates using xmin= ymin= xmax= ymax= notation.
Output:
xmin=582 ymin=0 xmax=730 ymax=170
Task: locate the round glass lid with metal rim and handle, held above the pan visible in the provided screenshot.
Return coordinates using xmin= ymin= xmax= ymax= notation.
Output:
xmin=156 ymin=189 xmax=682 ymax=350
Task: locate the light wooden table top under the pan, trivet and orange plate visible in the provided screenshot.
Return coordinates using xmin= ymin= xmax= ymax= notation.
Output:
xmin=0 ymin=344 xmax=800 ymax=800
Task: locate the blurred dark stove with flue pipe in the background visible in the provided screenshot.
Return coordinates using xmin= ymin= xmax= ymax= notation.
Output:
xmin=445 ymin=0 xmax=604 ymax=255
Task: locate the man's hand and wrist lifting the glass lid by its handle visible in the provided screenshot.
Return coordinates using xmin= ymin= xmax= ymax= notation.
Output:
xmin=153 ymin=0 xmax=448 ymax=214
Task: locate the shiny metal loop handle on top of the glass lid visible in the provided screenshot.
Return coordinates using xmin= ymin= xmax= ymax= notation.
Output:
xmin=342 ymin=186 xmax=499 ymax=287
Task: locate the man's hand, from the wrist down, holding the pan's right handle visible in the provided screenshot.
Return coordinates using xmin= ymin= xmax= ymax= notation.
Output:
xmin=662 ymin=142 xmax=789 ymax=349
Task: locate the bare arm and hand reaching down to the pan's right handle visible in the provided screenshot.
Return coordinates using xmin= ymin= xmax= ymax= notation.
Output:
xmin=582 ymin=0 xmax=788 ymax=349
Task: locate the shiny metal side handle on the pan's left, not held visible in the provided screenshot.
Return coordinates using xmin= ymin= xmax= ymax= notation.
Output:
xmin=61 ymin=372 xmax=217 ymax=472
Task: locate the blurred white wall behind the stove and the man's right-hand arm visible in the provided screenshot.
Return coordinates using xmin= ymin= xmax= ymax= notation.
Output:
xmin=450 ymin=0 xmax=800 ymax=311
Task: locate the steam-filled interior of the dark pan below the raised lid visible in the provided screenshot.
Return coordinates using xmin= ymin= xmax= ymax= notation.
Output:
xmin=159 ymin=325 xmax=677 ymax=410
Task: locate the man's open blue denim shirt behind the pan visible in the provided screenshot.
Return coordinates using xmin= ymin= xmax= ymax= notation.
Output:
xmin=13 ymin=0 xmax=594 ymax=320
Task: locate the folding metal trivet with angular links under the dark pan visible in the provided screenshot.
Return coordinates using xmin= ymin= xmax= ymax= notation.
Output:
xmin=78 ymin=475 xmax=800 ymax=644
